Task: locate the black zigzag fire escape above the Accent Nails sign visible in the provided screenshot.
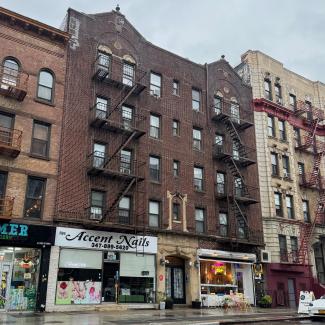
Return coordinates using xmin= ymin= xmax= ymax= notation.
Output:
xmin=87 ymin=53 xmax=146 ymax=223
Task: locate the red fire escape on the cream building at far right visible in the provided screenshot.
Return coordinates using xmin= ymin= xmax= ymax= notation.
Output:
xmin=295 ymin=102 xmax=325 ymax=265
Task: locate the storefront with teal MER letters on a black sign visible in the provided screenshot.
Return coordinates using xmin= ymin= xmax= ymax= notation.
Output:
xmin=0 ymin=223 xmax=55 ymax=311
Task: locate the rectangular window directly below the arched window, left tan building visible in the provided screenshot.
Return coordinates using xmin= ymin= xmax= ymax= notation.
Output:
xmin=31 ymin=121 xmax=51 ymax=157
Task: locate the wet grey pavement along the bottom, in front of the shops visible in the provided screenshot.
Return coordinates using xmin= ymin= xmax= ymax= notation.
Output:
xmin=0 ymin=308 xmax=306 ymax=325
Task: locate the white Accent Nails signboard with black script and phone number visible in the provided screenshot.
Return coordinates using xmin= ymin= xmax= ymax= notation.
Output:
xmin=55 ymin=227 xmax=157 ymax=254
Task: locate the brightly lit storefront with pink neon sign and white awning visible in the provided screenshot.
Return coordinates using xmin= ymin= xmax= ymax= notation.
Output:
xmin=198 ymin=249 xmax=256 ymax=305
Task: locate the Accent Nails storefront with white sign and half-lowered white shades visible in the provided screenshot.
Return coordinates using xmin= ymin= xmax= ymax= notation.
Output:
xmin=47 ymin=227 xmax=157 ymax=310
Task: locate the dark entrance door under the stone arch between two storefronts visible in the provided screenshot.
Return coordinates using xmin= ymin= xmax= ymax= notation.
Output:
xmin=166 ymin=257 xmax=186 ymax=304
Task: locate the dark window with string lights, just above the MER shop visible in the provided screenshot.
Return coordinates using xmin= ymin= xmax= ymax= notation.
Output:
xmin=24 ymin=177 xmax=46 ymax=219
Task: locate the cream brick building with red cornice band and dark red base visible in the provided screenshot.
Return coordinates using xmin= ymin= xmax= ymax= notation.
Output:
xmin=236 ymin=51 xmax=325 ymax=307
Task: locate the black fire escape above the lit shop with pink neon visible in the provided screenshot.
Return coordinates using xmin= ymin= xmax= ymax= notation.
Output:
xmin=212 ymin=98 xmax=260 ymax=242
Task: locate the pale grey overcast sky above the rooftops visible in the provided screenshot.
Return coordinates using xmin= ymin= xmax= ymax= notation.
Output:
xmin=0 ymin=0 xmax=325 ymax=82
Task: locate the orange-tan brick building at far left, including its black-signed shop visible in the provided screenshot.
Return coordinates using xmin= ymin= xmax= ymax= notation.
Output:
xmin=0 ymin=7 xmax=68 ymax=310
